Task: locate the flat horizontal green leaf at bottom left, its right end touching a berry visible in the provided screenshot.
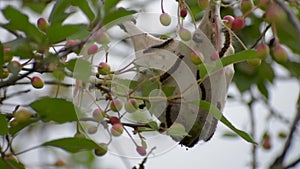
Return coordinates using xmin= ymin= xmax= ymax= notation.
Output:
xmin=41 ymin=138 xmax=100 ymax=153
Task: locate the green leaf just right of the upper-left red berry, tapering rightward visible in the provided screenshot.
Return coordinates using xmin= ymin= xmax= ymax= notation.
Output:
xmin=47 ymin=23 xmax=87 ymax=44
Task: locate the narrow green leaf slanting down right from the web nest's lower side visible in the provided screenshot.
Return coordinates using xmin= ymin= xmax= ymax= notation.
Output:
xmin=197 ymin=100 xmax=257 ymax=144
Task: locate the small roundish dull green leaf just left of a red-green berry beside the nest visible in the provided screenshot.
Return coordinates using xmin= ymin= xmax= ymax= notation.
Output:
xmin=73 ymin=59 xmax=92 ymax=82
